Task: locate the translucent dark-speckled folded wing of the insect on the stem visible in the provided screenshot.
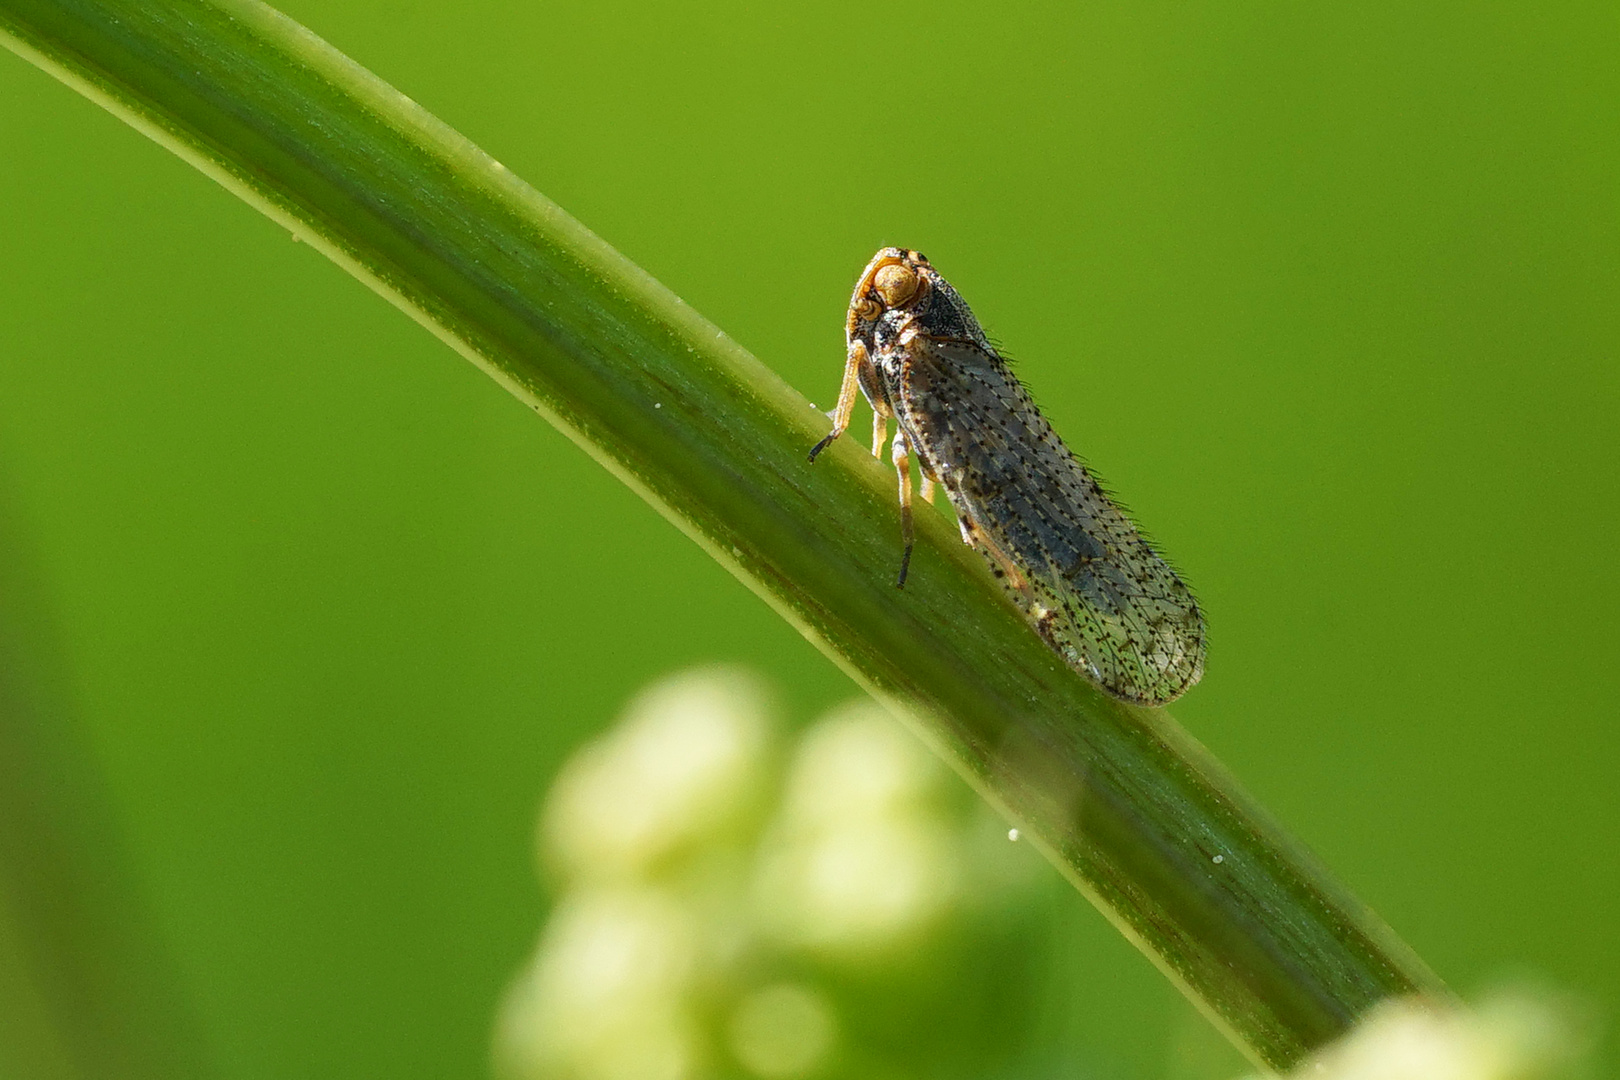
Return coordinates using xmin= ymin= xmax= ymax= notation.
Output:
xmin=894 ymin=335 xmax=1205 ymax=704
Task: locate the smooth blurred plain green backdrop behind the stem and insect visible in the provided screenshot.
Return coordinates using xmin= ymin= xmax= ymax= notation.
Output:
xmin=0 ymin=0 xmax=1620 ymax=1080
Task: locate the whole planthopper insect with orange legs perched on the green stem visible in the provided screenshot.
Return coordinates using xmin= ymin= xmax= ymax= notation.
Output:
xmin=810 ymin=248 xmax=1205 ymax=704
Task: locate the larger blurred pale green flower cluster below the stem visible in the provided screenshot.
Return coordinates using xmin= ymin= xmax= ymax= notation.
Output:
xmin=497 ymin=669 xmax=1042 ymax=1080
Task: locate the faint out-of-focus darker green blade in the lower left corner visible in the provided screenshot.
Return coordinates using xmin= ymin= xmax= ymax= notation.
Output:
xmin=0 ymin=505 xmax=207 ymax=1080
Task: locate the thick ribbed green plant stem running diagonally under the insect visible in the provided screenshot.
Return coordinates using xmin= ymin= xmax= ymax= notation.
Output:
xmin=0 ymin=0 xmax=1445 ymax=1067
